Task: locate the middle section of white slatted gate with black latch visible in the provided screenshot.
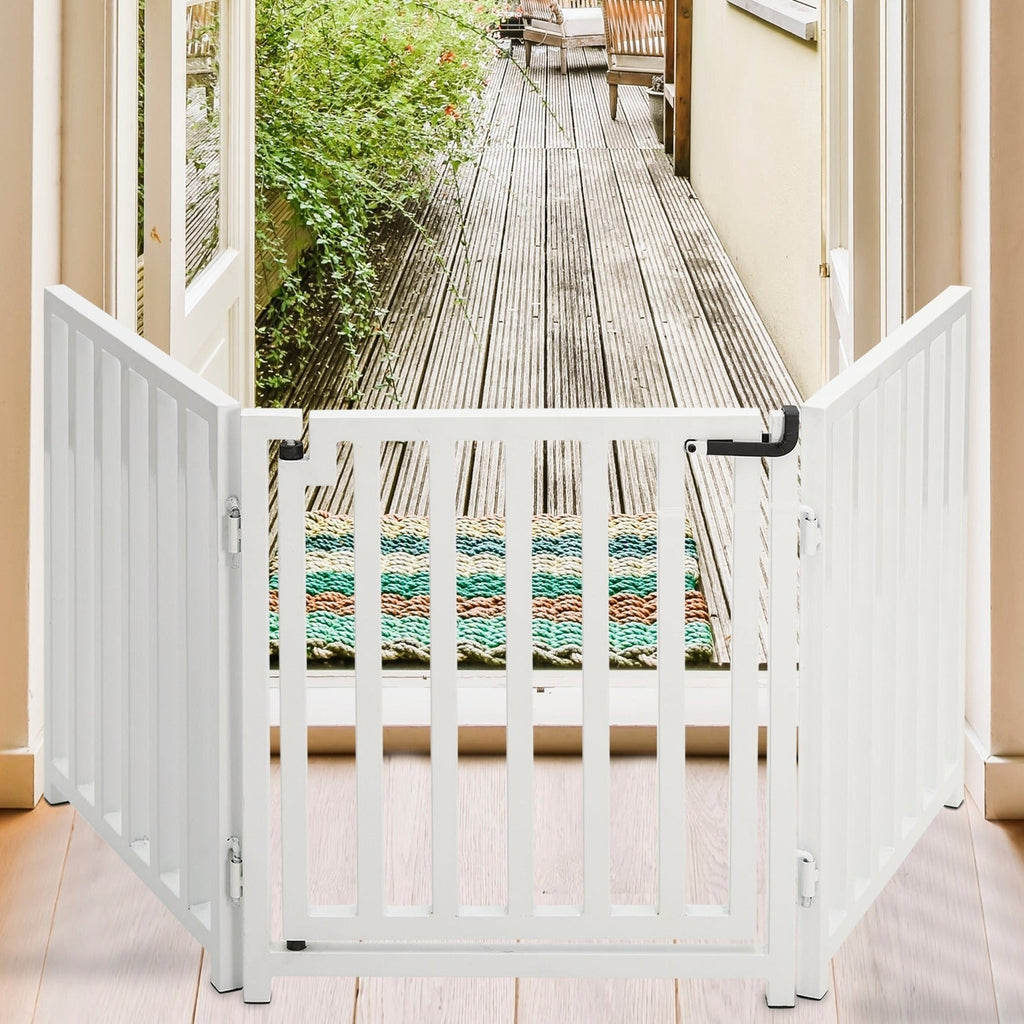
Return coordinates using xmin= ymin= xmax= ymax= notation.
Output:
xmin=243 ymin=410 xmax=798 ymax=1005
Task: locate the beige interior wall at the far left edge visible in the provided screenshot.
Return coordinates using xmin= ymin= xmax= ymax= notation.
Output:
xmin=0 ymin=0 xmax=60 ymax=807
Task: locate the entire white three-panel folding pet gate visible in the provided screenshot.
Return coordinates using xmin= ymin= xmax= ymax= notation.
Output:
xmin=39 ymin=288 xmax=970 ymax=1006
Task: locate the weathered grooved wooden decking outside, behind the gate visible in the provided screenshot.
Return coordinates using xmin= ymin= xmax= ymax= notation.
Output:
xmin=285 ymin=47 xmax=798 ymax=663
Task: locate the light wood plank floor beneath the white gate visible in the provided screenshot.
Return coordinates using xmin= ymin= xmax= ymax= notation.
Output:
xmin=0 ymin=755 xmax=1024 ymax=1024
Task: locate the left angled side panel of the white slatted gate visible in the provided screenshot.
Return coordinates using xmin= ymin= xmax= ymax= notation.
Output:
xmin=45 ymin=288 xmax=241 ymax=989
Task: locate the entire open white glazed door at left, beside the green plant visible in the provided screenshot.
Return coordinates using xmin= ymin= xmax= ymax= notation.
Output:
xmin=141 ymin=0 xmax=254 ymax=404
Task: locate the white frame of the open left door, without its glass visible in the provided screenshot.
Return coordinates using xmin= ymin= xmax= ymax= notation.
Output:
xmin=141 ymin=0 xmax=255 ymax=404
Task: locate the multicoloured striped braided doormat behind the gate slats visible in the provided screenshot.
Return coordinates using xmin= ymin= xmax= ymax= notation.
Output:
xmin=270 ymin=512 xmax=713 ymax=668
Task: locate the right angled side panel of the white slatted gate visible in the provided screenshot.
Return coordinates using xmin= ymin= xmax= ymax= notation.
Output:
xmin=798 ymin=288 xmax=970 ymax=996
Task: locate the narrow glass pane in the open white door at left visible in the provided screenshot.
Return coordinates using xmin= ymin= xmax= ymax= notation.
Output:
xmin=184 ymin=0 xmax=221 ymax=284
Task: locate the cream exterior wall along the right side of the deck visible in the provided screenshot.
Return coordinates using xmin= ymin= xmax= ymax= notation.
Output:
xmin=690 ymin=0 xmax=822 ymax=396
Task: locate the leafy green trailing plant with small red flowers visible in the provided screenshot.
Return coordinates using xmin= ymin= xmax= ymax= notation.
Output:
xmin=256 ymin=0 xmax=496 ymax=404
